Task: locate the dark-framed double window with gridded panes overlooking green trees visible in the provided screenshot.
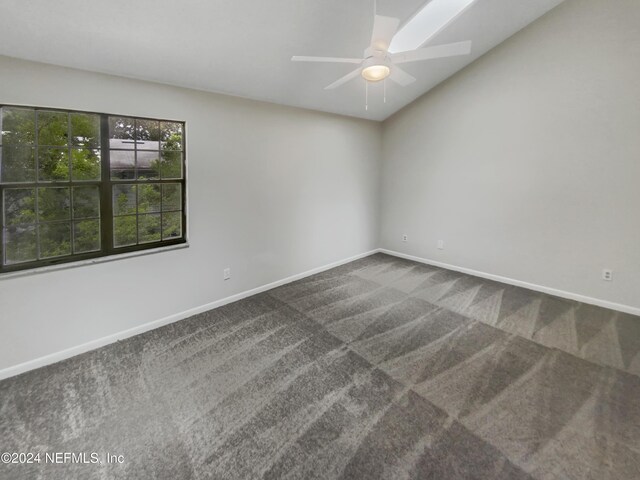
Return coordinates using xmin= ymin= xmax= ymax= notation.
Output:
xmin=0 ymin=106 xmax=186 ymax=272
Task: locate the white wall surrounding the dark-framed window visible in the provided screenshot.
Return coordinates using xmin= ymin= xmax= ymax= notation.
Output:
xmin=0 ymin=57 xmax=381 ymax=370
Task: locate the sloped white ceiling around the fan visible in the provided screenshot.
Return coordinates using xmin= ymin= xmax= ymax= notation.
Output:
xmin=0 ymin=0 xmax=563 ymax=120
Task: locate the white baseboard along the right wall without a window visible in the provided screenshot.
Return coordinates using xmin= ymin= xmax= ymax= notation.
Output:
xmin=378 ymin=248 xmax=640 ymax=316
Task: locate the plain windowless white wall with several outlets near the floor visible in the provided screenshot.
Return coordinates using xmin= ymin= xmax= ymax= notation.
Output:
xmin=381 ymin=0 xmax=640 ymax=307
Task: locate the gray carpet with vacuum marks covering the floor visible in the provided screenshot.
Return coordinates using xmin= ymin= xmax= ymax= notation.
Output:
xmin=0 ymin=254 xmax=640 ymax=480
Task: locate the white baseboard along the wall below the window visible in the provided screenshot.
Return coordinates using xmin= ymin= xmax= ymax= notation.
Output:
xmin=0 ymin=249 xmax=378 ymax=380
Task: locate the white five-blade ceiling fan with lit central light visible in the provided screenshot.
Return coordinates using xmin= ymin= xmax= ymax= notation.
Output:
xmin=291 ymin=15 xmax=471 ymax=90
